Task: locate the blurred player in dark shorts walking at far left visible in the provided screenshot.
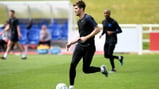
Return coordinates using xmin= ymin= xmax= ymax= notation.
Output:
xmin=0 ymin=10 xmax=26 ymax=59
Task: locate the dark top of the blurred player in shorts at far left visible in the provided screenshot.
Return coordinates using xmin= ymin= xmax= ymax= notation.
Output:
xmin=8 ymin=18 xmax=19 ymax=39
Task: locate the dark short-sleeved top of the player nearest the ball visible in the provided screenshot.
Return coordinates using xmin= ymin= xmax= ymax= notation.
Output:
xmin=78 ymin=14 xmax=97 ymax=45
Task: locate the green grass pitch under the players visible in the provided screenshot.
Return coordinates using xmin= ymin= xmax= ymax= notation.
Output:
xmin=0 ymin=54 xmax=159 ymax=89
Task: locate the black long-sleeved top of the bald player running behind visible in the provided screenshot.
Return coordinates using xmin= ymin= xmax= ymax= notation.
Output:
xmin=102 ymin=18 xmax=122 ymax=43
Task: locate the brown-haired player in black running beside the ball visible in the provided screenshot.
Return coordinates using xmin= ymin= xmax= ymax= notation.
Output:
xmin=66 ymin=0 xmax=108 ymax=89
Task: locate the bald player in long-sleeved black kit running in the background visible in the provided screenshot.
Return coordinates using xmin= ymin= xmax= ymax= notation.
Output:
xmin=99 ymin=10 xmax=123 ymax=73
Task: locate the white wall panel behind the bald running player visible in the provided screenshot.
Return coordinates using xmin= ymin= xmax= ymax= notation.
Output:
xmin=95 ymin=25 xmax=142 ymax=54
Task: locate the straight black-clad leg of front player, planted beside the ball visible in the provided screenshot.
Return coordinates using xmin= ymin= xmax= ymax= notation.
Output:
xmin=69 ymin=45 xmax=83 ymax=87
